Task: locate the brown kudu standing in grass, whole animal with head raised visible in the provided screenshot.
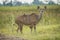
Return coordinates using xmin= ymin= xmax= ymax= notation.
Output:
xmin=15 ymin=8 xmax=45 ymax=33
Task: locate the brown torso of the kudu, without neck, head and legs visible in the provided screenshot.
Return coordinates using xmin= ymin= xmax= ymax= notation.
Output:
xmin=15 ymin=13 xmax=38 ymax=25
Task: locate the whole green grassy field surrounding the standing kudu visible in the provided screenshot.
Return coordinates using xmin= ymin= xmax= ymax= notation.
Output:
xmin=0 ymin=5 xmax=60 ymax=40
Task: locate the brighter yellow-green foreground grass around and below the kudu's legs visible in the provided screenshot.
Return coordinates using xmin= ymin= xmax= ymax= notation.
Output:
xmin=1 ymin=25 xmax=60 ymax=40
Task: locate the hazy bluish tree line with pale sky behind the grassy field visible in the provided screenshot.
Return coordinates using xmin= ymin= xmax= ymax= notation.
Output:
xmin=0 ymin=0 xmax=60 ymax=6
